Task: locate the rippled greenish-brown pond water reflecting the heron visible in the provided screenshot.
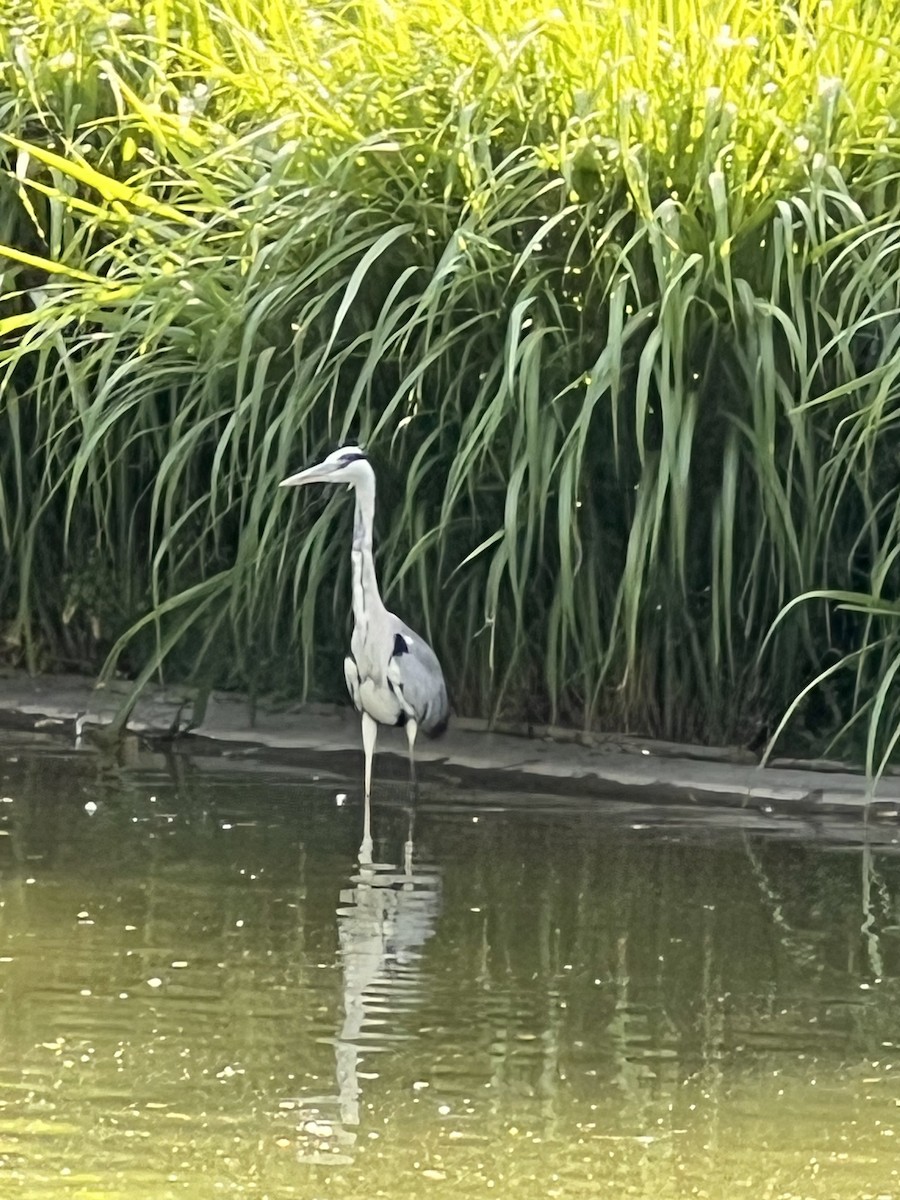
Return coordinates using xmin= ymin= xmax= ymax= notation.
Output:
xmin=0 ymin=734 xmax=900 ymax=1200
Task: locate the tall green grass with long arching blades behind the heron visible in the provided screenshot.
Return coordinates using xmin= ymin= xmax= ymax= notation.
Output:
xmin=0 ymin=0 xmax=900 ymax=739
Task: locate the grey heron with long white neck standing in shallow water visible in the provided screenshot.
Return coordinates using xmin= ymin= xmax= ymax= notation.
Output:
xmin=280 ymin=446 xmax=450 ymax=853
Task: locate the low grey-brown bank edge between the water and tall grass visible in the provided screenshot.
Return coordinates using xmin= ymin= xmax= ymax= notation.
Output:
xmin=0 ymin=671 xmax=900 ymax=816
